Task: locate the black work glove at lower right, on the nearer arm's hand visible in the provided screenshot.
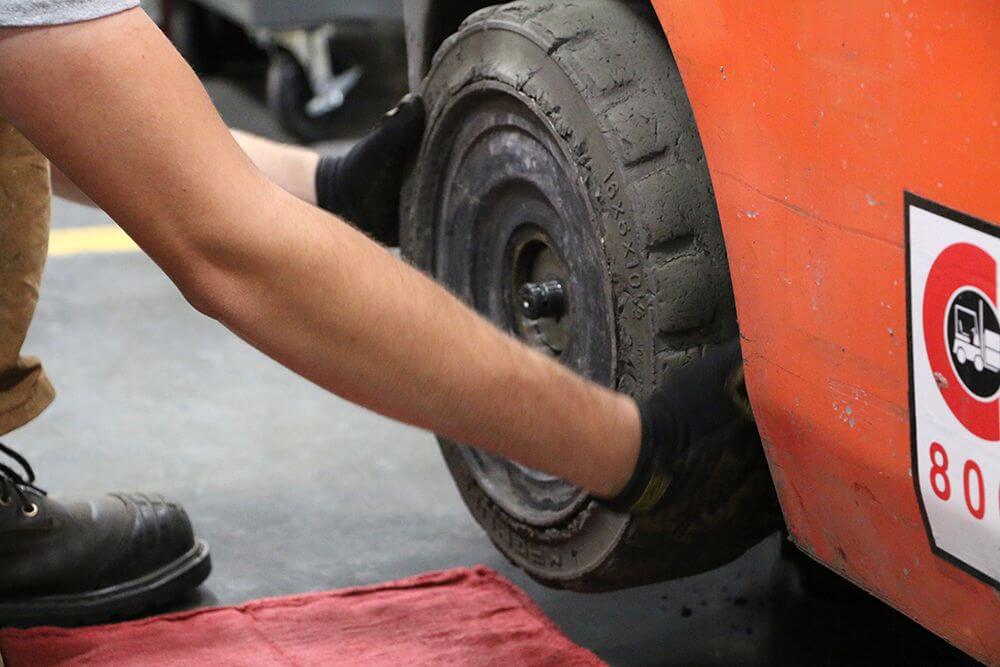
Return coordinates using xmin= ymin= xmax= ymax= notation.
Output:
xmin=607 ymin=340 xmax=756 ymax=514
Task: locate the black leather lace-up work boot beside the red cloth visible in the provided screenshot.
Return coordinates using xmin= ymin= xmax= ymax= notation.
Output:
xmin=0 ymin=444 xmax=212 ymax=627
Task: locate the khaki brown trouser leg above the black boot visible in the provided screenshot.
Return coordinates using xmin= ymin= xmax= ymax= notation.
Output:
xmin=0 ymin=119 xmax=55 ymax=435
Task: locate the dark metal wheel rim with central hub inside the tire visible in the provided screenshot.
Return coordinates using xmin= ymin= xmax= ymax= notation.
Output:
xmin=432 ymin=84 xmax=614 ymax=525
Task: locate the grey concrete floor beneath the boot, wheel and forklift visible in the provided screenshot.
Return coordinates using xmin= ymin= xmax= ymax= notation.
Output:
xmin=8 ymin=65 xmax=976 ymax=665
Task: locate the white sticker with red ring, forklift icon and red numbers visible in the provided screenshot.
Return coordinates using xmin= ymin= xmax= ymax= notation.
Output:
xmin=905 ymin=194 xmax=1000 ymax=587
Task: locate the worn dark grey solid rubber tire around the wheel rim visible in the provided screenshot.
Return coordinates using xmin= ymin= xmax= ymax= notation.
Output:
xmin=401 ymin=0 xmax=781 ymax=591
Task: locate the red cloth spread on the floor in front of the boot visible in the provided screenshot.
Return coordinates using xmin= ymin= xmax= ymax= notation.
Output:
xmin=0 ymin=567 xmax=604 ymax=667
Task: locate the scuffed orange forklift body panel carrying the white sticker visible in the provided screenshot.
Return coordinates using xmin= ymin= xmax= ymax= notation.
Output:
xmin=653 ymin=0 xmax=1000 ymax=664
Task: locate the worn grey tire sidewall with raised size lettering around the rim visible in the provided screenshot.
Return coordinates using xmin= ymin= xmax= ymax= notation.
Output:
xmin=401 ymin=18 xmax=654 ymax=587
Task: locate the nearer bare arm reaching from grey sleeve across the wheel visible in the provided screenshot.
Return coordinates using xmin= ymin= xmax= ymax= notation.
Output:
xmin=0 ymin=10 xmax=639 ymax=495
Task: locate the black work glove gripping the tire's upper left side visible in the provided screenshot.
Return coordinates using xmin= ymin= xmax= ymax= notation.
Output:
xmin=316 ymin=95 xmax=424 ymax=246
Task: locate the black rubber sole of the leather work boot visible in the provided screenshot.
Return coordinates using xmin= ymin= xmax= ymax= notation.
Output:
xmin=0 ymin=540 xmax=212 ymax=628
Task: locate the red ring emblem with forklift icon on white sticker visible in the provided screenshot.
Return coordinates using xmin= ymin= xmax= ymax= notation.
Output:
xmin=922 ymin=243 xmax=1000 ymax=442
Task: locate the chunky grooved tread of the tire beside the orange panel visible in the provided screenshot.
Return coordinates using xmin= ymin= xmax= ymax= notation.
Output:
xmin=408 ymin=0 xmax=780 ymax=591
